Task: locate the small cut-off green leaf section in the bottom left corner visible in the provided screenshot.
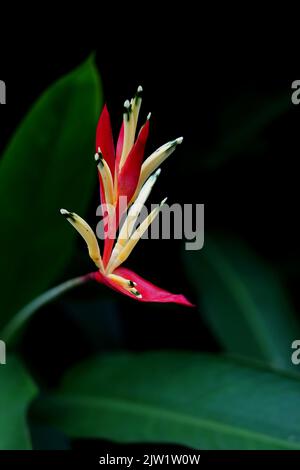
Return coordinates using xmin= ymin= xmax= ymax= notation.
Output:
xmin=0 ymin=357 xmax=36 ymax=450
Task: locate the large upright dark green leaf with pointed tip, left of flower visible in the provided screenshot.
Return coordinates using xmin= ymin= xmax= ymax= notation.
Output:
xmin=0 ymin=58 xmax=101 ymax=325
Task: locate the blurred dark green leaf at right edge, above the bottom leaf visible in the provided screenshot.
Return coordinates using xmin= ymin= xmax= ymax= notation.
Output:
xmin=185 ymin=237 xmax=300 ymax=368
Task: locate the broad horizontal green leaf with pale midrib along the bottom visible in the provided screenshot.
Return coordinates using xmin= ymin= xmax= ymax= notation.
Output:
xmin=34 ymin=352 xmax=300 ymax=449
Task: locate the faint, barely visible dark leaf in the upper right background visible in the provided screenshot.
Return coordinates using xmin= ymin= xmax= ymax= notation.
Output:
xmin=197 ymin=92 xmax=291 ymax=167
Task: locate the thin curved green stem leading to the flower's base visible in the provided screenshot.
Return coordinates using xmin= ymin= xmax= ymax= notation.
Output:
xmin=0 ymin=274 xmax=90 ymax=344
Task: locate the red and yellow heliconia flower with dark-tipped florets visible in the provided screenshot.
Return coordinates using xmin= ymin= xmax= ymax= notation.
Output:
xmin=60 ymin=87 xmax=192 ymax=306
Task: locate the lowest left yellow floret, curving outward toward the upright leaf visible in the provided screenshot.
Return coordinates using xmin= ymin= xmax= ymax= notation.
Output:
xmin=60 ymin=209 xmax=104 ymax=272
